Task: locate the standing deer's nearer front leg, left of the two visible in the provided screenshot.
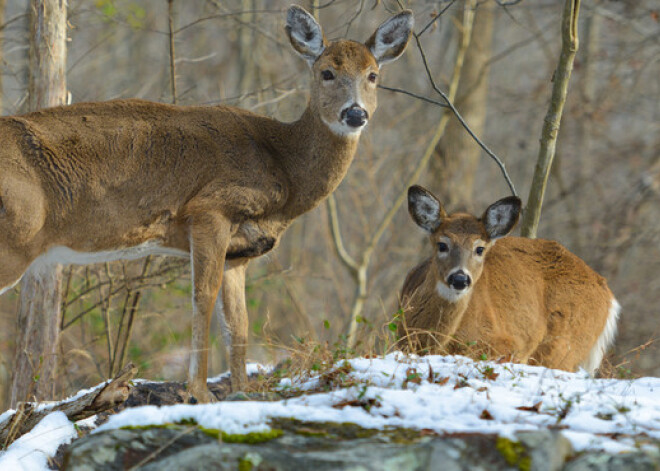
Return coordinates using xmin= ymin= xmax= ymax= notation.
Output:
xmin=188 ymin=214 xmax=231 ymax=402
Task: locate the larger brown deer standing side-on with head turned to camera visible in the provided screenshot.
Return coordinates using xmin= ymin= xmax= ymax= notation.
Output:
xmin=0 ymin=5 xmax=414 ymax=402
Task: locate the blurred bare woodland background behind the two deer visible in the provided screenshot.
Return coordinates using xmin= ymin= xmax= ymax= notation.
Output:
xmin=0 ymin=0 xmax=660 ymax=410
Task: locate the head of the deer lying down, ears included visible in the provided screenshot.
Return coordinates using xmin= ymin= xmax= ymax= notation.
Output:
xmin=408 ymin=186 xmax=521 ymax=302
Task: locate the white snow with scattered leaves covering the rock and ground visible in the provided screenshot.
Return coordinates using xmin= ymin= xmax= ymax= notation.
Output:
xmin=0 ymin=353 xmax=660 ymax=469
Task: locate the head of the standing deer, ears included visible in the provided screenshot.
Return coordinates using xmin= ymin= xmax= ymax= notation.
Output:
xmin=286 ymin=6 xmax=413 ymax=137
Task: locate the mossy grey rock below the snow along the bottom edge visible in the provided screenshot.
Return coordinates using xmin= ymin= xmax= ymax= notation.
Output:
xmin=63 ymin=420 xmax=590 ymax=471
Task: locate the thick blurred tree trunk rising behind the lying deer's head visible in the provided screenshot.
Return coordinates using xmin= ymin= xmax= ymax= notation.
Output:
xmin=429 ymin=2 xmax=495 ymax=209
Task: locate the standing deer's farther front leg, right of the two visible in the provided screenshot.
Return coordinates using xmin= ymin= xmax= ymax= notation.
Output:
xmin=216 ymin=260 xmax=248 ymax=392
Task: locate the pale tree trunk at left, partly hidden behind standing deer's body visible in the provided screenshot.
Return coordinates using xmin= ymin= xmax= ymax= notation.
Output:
xmin=11 ymin=0 xmax=67 ymax=407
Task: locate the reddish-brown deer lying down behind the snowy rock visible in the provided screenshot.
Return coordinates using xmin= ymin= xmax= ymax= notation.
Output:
xmin=397 ymin=185 xmax=620 ymax=376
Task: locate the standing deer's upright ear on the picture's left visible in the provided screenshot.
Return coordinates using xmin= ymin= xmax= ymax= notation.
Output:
xmin=285 ymin=5 xmax=327 ymax=66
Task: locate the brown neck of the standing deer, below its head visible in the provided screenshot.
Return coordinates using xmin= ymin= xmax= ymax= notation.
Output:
xmin=281 ymin=106 xmax=359 ymax=218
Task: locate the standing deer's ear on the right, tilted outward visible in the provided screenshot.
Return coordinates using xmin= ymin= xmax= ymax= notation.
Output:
xmin=365 ymin=10 xmax=415 ymax=67
